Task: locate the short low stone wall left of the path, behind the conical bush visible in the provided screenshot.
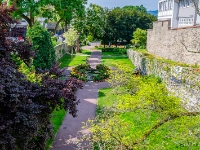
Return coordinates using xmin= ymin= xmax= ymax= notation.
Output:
xmin=54 ymin=43 xmax=72 ymax=60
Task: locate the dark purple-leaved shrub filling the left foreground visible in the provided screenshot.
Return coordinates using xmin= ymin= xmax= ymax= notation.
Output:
xmin=0 ymin=9 xmax=81 ymax=150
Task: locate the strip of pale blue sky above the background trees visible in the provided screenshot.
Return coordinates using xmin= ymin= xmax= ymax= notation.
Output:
xmin=87 ymin=0 xmax=158 ymax=10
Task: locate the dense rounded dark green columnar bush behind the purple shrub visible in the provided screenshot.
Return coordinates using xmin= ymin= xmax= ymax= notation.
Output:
xmin=27 ymin=23 xmax=56 ymax=69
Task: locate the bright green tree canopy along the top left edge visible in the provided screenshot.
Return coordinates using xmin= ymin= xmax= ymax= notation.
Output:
xmin=9 ymin=0 xmax=86 ymax=31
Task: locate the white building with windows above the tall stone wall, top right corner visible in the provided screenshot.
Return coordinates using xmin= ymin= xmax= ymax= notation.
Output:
xmin=158 ymin=0 xmax=200 ymax=28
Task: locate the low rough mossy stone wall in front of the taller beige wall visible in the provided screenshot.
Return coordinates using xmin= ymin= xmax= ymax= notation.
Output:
xmin=128 ymin=50 xmax=200 ymax=111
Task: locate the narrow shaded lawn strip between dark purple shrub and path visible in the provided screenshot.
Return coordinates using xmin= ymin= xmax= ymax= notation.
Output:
xmin=46 ymin=109 xmax=66 ymax=150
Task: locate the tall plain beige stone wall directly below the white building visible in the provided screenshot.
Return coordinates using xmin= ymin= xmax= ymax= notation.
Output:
xmin=147 ymin=21 xmax=200 ymax=65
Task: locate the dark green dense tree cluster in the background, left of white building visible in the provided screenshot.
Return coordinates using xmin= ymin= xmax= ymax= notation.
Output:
xmin=106 ymin=6 xmax=156 ymax=44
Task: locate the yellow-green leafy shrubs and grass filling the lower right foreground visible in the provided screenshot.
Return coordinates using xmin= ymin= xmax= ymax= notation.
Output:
xmin=80 ymin=65 xmax=200 ymax=150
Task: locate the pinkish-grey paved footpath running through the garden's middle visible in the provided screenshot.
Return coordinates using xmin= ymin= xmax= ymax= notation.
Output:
xmin=52 ymin=47 xmax=109 ymax=150
